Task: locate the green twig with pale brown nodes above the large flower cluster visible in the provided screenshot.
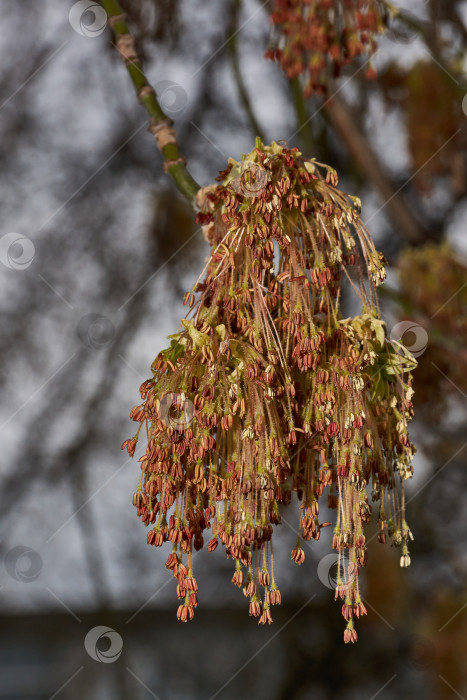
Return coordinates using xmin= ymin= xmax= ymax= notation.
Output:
xmin=101 ymin=0 xmax=200 ymax=202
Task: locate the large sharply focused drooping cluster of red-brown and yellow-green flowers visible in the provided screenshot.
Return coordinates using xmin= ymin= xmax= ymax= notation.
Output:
xmin=122 ymin=141 xmax=415 ymax=641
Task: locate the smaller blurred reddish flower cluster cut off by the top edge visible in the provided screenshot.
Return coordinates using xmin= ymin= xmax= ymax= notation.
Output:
xmin=266 ymin=0 xmax=393 ymax=97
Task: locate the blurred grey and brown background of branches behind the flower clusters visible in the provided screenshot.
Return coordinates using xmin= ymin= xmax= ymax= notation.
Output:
xmin=0 ymin=0 xmax=467 ymax=700
